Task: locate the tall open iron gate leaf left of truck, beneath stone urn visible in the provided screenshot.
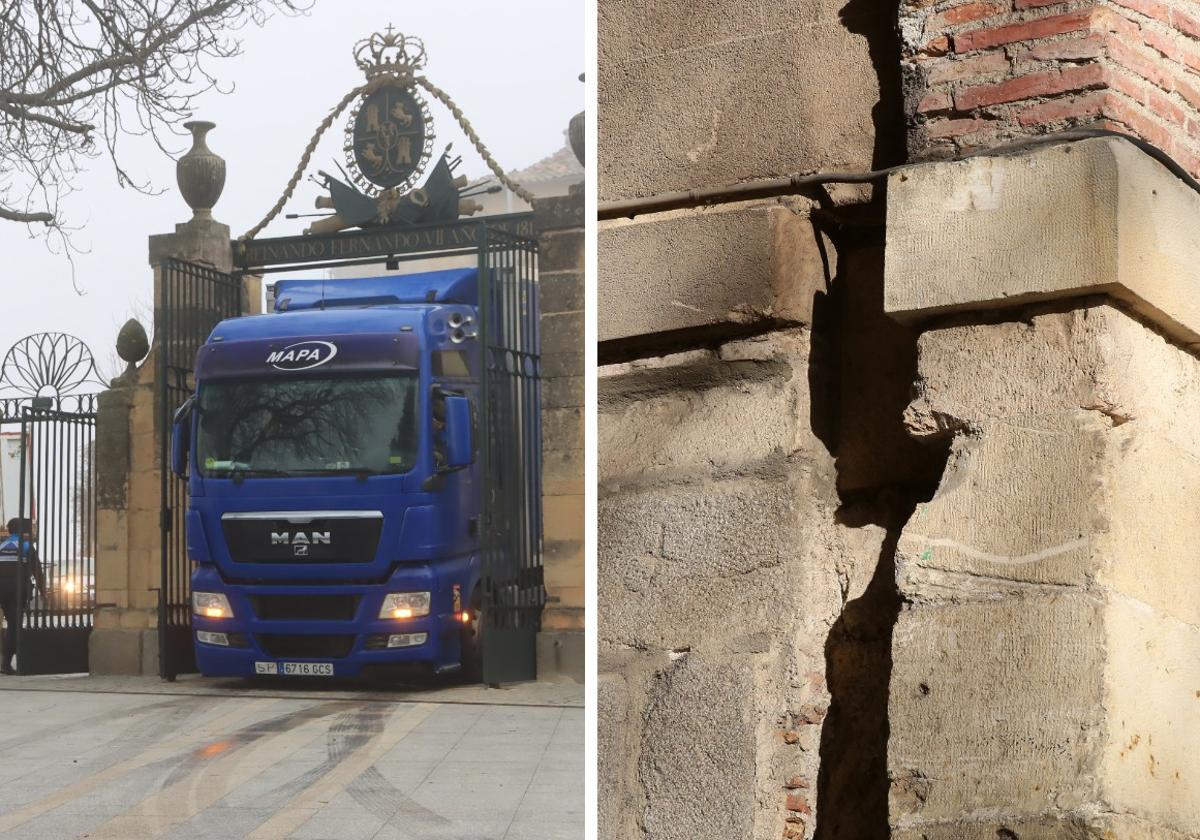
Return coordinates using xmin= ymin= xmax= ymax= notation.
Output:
xmin=156 ymin=259 xmax=241 ymax=680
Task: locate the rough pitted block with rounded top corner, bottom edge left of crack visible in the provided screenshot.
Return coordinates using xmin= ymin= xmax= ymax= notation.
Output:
xmin=638 ymin=653 xmax=757 ymax=840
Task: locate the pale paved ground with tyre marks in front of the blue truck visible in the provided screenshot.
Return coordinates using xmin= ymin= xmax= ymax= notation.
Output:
xmin=0 ymin=677 xmax=583 ymax=840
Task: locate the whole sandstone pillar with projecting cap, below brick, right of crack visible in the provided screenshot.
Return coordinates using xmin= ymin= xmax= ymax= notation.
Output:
xmin=884 ymin=139 xmax=1200 ymax=840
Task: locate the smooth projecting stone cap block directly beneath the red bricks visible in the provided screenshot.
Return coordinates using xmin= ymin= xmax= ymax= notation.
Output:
xmin=884 ymin=138 xmax=1200 ymax=343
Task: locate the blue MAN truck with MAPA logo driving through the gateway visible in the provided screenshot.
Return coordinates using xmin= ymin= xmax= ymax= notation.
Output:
xmin=172 ymin=269 xmax=541 ymax=679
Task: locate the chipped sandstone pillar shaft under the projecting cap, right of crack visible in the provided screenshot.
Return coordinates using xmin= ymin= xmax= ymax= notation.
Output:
xmin=888 ymin=299 xmax=1200 ymax=840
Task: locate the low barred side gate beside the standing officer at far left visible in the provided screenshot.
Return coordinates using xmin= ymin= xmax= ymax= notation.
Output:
xmin=15 ymin=403 xmax=96 ymax=674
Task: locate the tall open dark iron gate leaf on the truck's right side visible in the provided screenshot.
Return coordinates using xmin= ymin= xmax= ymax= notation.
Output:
xmin=478 ymin=223 xmax=546 ymax=684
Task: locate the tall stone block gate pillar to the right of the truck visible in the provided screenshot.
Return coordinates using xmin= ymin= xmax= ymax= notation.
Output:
xmin=533 ymin=185 xmax=584 ymax=682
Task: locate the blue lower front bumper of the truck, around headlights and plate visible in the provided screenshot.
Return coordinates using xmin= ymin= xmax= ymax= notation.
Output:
xmin=192 ymin=568 xmax=462 ymax=677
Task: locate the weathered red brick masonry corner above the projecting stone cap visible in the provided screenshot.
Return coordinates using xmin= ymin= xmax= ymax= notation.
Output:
xmin=900 ymin=0 xmax=1200 ymax=173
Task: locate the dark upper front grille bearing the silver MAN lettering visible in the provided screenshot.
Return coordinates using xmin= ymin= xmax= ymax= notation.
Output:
xmin=221 ymin=511 xmax=383 ymax=564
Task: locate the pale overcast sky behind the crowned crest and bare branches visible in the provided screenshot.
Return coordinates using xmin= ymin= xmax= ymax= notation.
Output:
xmin=0 ymin=0 xmax=583 ymax=376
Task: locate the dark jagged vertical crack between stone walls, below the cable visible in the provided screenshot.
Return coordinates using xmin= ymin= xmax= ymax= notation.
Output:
xmin=810 ymin=229 xmax=949 ymax=840
